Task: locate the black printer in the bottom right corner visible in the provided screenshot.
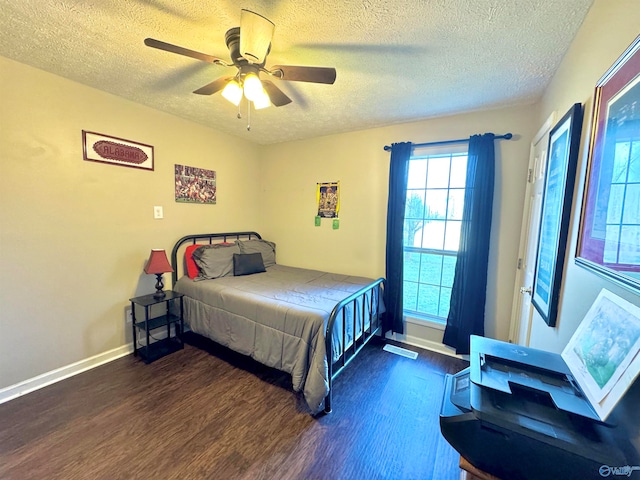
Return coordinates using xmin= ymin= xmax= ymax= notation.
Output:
xmin=440 ymin=336 xmax=640 ymax=480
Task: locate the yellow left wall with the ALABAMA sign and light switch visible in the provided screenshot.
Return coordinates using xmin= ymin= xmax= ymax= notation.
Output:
xmin=0 ymin=57 xmax=260 ymax=389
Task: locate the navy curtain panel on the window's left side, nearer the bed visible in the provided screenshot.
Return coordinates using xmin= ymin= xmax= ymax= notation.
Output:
xmin=382 ymin=142 xmax=411 ymax=333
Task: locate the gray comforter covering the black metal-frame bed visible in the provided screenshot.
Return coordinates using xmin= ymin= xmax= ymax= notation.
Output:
xmin=174 ymin=265 xmax=377 ymax=413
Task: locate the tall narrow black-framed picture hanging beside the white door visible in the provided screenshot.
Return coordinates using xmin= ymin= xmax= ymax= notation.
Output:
xmin=531 ymin=103 xmax=582 ymax=327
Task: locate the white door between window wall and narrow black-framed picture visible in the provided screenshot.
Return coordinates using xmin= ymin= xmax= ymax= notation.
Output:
xmin=509 ymin=112 xmax=555 ymax=346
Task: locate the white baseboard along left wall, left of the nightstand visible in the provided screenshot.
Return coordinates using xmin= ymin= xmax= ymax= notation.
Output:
xmin=0 ymin=345 xmax=133 ymax=403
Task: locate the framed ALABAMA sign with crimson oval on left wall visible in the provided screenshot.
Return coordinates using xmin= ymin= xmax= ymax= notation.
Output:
xmin=82 ymin=130 xmax=153 ymax=170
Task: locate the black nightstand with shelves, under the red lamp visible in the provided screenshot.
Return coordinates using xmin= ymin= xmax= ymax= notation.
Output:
xmin=129 ymin=290 xmax=184 ymax=363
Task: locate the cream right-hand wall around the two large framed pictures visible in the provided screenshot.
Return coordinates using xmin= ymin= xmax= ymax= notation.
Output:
xmin=530 ymin=0 xmax=640 ymax=352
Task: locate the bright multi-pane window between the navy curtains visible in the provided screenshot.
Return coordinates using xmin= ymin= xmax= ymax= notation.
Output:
xmin=403 ymin=145 xmax=467 ymax=323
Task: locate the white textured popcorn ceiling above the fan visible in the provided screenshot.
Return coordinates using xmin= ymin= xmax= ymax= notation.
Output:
xmin=0 ymin=0 xmax=593 ymax=144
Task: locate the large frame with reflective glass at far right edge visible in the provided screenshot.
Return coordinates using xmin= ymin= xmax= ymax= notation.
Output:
xmin=576 ymin=37 xmax=640 ymax=291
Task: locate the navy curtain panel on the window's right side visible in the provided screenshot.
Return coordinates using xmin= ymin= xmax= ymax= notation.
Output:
xmin=442 ymin=133 xmax=495 ymax=354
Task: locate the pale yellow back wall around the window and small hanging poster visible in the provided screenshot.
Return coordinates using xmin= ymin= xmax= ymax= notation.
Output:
xmin=260 ymin=105 xmax=538 ymax=343
